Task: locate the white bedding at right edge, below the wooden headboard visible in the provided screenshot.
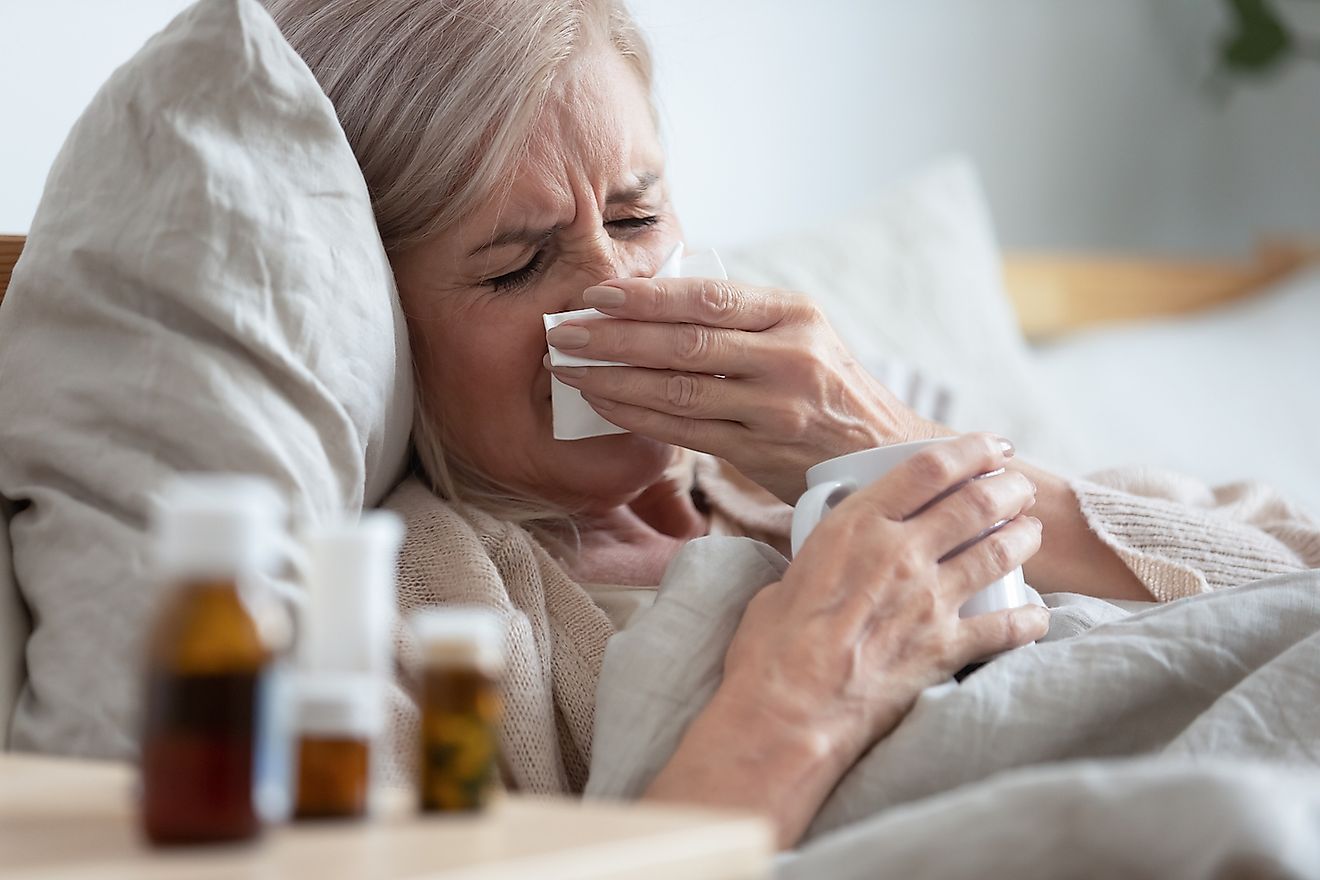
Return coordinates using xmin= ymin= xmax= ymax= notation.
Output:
xmin=1029 ymin=268 xmax=1320 ymax=515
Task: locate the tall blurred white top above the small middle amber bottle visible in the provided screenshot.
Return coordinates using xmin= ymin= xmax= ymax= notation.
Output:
xmin=298 ymin=511 xmax=404 ymax=678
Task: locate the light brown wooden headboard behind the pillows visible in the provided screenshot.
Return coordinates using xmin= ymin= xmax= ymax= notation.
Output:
xmin=0 ymin=235 xmax=1320 ymax=339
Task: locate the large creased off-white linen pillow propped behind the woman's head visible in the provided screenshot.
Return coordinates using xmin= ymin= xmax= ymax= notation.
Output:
xmin=0 ymin=0 xmax=412 ymax=756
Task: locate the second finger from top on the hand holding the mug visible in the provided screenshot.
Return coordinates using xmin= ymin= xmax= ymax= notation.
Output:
xmin=909 ymin=470 xmax=1036 ymax=562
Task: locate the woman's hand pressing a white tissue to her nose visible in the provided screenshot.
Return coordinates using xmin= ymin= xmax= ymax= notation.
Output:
xmin=546 ymin=278 xmax=948 ymax=504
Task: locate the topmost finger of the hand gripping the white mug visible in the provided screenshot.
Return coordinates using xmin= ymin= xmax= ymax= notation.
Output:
xmin=850 ymin=434 xmax=1014 ymax=520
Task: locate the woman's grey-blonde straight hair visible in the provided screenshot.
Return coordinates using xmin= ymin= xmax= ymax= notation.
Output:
xmin=265 ymin=0 xmax=652 ymax=537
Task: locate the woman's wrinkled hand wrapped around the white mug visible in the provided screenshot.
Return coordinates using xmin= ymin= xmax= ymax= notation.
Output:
xmin=725 ymin=434 xmax=1048 ymax=786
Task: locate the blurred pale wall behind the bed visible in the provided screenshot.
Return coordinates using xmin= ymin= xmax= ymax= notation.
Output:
xmin=0 ymin=0 xmax=1320 ymax=251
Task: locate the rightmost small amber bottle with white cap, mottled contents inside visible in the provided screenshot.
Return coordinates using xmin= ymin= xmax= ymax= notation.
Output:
xmin=412 ymin=607 xmax=504 ymax=813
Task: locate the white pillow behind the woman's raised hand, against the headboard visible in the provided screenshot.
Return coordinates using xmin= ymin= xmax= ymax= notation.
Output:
xmin=725 ymin=158 xmax=1074 ymax=472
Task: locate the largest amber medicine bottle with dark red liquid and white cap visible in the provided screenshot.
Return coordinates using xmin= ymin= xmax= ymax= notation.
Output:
xmin=141 ymin=475 xmax=289 ymax=844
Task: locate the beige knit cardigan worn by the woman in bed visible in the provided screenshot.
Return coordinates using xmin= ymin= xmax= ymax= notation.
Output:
xmin=385 ymin=467 xmax=1320 ymax=793
